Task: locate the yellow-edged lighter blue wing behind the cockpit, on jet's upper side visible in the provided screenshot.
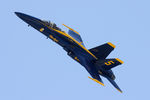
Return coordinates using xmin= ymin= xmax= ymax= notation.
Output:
xmin=63 ymin=24 xmax=85 ymax=47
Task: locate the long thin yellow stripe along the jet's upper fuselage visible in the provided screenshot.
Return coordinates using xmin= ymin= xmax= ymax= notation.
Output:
xmin=38 ymin=21 xmax=97 ymax=59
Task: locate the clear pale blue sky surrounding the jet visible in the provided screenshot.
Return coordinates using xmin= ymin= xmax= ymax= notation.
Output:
xmin=0 ymin=0 xmax=150 ymax=100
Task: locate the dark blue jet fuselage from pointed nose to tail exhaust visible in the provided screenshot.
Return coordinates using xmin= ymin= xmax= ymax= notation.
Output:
xmin=16 ymin=12 xmax=123 ymax=92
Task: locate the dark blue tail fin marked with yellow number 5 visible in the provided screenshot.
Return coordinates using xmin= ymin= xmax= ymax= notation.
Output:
xmin=96 ymin=58 xmax=123 ymax=70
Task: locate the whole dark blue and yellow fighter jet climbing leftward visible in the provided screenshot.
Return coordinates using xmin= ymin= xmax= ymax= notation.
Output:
xmin=15 ymin=12 xmax=123 ymax=92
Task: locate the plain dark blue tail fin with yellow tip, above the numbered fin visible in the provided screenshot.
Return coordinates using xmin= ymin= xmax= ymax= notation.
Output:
xmin=89 ymin=42 xmax=115 ymax=59
